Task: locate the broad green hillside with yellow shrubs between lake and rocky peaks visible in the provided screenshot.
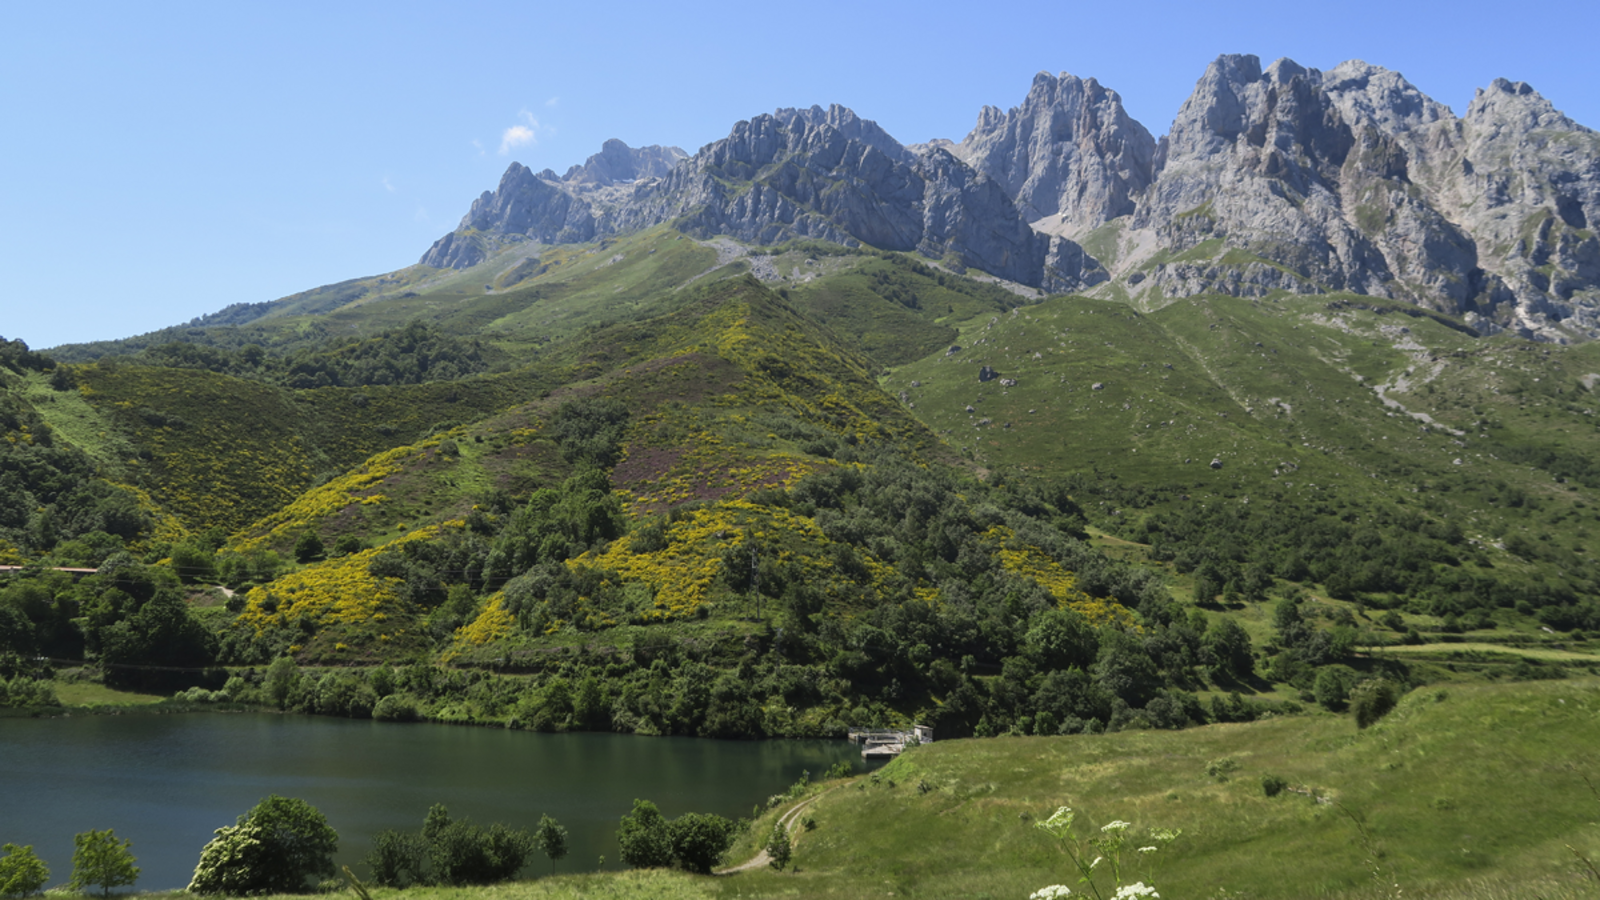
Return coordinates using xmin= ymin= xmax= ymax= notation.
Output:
xmin=0 ymin=227 xmax=1600 ymax=737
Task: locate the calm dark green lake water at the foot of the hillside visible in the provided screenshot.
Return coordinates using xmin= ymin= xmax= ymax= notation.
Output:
xmin=0 ymin=713 xmax=861 ymax=890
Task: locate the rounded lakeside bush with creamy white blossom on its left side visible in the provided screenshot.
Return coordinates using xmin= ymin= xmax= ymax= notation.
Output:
xmin=189 ymin=794 xmax=339 ymax=895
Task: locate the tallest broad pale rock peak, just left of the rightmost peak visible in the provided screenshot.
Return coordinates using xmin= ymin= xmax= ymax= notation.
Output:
xmin=1134 ymin=54 xmax=1488 ymax=311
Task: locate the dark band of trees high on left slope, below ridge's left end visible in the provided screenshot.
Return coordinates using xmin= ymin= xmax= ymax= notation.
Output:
xmin=128 ymin=320 xmax=496 ymax=389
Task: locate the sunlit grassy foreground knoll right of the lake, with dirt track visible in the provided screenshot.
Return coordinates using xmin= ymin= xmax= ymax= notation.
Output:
xmin=736 ymin=679 xmax=1600 ymax=898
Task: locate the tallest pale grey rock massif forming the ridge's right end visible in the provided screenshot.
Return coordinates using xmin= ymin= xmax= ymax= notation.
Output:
xmin=1125 ymin=56 xmax=1600 ymax=340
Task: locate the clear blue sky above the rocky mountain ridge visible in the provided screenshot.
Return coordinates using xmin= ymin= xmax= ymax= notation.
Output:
xmin=0 ymin=0 xmax=1600 ymax=348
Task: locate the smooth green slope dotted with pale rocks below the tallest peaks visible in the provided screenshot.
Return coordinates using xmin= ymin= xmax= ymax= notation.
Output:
xmin=883 ymin=291 xmax=1600 ymax=565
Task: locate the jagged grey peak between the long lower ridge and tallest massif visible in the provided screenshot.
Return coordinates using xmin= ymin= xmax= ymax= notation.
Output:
xmin=954 ymin=72 xmax=1155 ymax=234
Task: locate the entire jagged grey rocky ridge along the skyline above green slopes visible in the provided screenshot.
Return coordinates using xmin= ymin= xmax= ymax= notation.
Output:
xmin=422 ymin=54 xmax=1600 ymax=341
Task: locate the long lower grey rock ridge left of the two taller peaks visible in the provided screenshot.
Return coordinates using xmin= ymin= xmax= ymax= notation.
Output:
xmin=422 ymin=106 xmax=1104 ymax=290
